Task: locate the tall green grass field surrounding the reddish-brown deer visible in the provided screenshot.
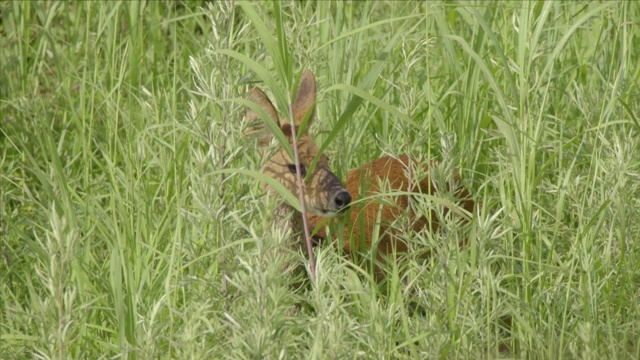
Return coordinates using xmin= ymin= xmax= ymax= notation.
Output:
xmin=0 ymin=1 xmax=640 ymax=359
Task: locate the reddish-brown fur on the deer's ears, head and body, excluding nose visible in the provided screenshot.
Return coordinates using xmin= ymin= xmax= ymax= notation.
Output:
xmin=247 ymin=70 xmax=475 ymax=266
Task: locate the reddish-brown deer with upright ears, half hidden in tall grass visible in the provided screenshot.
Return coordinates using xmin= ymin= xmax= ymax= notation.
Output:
xmin=245 ymin=70 xmax=476 ymax=278
